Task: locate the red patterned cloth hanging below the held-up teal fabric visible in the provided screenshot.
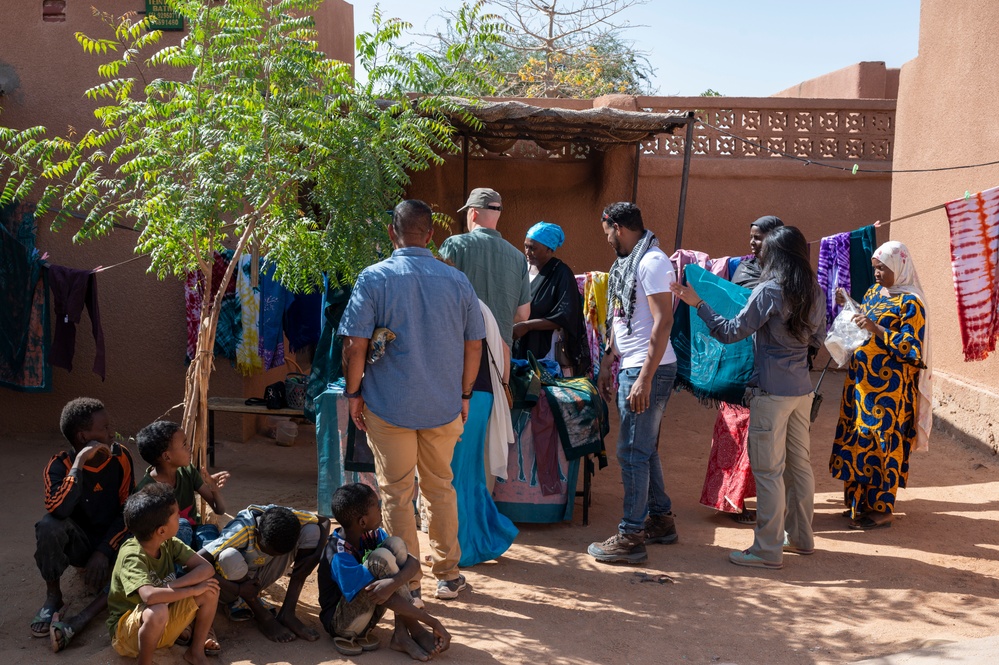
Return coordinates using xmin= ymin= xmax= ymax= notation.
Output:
xmin=701 ymin=402 xmax=756 ymax=513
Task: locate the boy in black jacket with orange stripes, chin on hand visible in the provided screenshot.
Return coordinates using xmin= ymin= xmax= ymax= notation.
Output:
xmin=31 ymin=397 xmax=135 ymax=651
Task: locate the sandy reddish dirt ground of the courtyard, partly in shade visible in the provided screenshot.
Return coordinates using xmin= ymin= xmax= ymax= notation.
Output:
xmin=0 ymin=370 xmax=999 ymax=665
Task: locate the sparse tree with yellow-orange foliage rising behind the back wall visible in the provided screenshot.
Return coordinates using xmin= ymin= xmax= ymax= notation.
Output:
xmin=414 ymin=0 xmax=655 ymax=98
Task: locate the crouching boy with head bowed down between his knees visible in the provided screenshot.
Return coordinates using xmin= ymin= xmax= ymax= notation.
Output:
xmin=200 ymin=505 xmax=330 ymax=642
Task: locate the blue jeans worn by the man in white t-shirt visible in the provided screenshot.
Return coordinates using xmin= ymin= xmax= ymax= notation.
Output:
xmin=617 ymin=363 xmax=676 ymax=533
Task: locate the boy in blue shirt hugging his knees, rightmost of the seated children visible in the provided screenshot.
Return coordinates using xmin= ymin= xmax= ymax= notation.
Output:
xmin=318 ymin=483 xmax=451 ymax=660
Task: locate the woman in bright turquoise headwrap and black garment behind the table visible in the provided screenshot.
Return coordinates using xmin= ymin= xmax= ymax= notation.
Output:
xmin=513 ymin=222 xmax=590 ymax=376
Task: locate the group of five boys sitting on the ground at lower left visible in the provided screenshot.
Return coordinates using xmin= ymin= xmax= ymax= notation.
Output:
xmin=31 ymin=398 xmax=451 ymax=664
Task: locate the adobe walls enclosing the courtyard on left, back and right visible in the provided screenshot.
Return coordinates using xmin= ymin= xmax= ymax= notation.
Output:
xmin=7 ymin=0 xmax=999 ymax=454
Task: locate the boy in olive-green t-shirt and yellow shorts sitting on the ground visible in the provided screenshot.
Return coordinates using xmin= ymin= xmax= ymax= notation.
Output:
xmin=107 ymin=483 xmax=221 ymax=665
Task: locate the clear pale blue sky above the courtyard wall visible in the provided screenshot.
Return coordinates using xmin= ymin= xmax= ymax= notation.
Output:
xmin=348 ymin=0 xmax=919 ymax=97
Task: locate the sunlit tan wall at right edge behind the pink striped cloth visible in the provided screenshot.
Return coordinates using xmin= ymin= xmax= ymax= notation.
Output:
xmin=891 ymin=0 xmax=999 ymax=449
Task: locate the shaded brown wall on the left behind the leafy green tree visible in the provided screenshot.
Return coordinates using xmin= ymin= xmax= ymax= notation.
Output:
xmin=0 ymin=0 xmax=353 ymax=436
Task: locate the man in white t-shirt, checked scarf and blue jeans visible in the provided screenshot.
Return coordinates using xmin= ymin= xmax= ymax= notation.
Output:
xmin=587 ymin=203 xmax=678 ymax=563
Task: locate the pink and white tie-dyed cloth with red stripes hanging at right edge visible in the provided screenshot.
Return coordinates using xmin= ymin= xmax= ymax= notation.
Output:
xmin=945 ymin=187 xmax=999 ymax=361
